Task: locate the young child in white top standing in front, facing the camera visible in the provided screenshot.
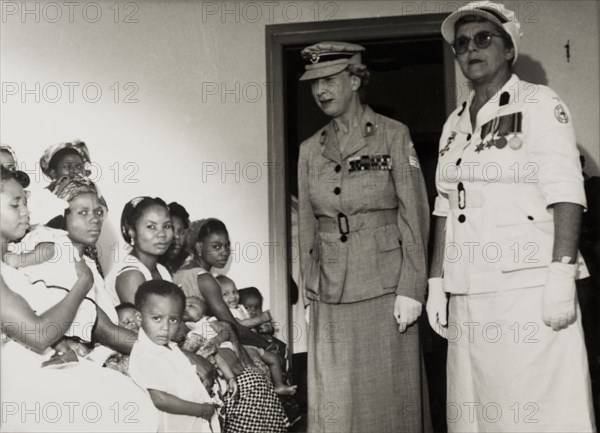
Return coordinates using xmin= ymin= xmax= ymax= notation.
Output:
xmin=129 ymin=280 xmax=221 ymax=432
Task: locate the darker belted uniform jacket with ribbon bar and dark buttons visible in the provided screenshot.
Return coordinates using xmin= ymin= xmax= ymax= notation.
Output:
xmin=298 ymin=107 xmax=429 ymax=304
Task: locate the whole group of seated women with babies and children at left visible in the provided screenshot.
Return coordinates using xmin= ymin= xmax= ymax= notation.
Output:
xmin=0 ymin=141 xmax=295 ymax=432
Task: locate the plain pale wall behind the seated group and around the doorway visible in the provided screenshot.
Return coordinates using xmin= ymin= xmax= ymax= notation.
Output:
xmin=0 ymin=0 xmax=600 ymax=314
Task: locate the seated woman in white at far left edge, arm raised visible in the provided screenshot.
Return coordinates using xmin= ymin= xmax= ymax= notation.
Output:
xmin=0 ymin=167 xmax=158 ymax=432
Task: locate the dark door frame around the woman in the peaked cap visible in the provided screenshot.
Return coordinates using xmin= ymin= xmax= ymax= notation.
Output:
xmin=265 ymin=13 xmax=456 ymax=353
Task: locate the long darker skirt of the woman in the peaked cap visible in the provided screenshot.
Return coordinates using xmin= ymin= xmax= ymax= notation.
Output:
xmin=307 ymin=294 xmax=431 ymax=433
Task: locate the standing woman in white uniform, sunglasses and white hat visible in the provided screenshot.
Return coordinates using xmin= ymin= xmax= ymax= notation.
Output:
xmin=427 ymin=1 xmax=595 ymax=432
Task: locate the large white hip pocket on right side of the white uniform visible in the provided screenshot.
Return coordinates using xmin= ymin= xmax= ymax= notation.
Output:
xmin=494 ymin=207 xmax=554 ymax=272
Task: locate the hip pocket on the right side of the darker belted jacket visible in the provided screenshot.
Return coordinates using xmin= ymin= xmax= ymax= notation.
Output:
xmin=375 ymin=226 xmax=402 ymax=289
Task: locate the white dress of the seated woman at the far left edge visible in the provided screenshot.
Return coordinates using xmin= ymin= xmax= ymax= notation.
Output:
xmin=0 ymin=263 xmax=158 ymax=432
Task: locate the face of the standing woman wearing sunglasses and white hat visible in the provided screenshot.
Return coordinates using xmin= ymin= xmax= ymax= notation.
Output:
xmin=453 ymin=21 xmax=514 ymax=86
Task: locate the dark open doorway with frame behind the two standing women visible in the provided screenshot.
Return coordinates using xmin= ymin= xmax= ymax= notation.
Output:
xmin=266 ymin=14 xmax=456 ymax=431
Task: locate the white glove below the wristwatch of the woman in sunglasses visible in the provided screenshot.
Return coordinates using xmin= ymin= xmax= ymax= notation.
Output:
xmin=542 ymin=262 xmax=577 ymax=331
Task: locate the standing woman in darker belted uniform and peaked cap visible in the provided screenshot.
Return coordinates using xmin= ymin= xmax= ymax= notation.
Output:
xmin=298 ymin=42 xmax=431 ymax=433
